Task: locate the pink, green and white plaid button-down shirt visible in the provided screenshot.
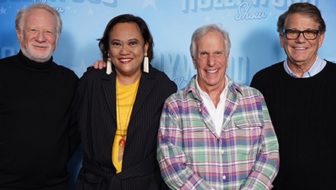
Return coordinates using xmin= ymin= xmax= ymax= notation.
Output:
xmin=157 ymin=77 xmax=279 ymax=190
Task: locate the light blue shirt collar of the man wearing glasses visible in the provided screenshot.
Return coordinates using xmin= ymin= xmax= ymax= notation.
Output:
xmin=283 ymin=56 xmax=327 ymax=78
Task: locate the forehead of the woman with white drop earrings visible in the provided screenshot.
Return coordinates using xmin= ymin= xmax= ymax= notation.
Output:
xmin=110 ymin=22 xmax=143 ymax=39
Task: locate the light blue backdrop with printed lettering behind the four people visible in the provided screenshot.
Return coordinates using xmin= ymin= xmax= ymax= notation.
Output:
xmin=0 ymin=0 xmax=336 ymax=188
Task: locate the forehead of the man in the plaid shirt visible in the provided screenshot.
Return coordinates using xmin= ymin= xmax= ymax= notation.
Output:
xmin=196 ymin=31 xmax=225 ymax=50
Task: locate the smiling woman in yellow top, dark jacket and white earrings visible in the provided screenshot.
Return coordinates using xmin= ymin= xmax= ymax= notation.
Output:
xmin=75 ymin=14 xmax=177 ymax=190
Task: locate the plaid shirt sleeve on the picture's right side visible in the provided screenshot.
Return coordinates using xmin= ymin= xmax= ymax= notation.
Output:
xmin=241 ymin=94 xmax=280 ymax=190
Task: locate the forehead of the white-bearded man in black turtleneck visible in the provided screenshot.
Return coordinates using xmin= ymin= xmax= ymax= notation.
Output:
xmin=23 ymin=8 xmax=57 ymax=28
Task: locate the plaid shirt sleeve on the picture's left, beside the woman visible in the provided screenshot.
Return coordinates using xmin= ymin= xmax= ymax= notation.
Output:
xmin=157 ymin=100 xmax=212 ymax=190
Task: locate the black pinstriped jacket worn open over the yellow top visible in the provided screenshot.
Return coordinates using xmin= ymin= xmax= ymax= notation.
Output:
xmin=76 ymin=68 xmax=176 ymax=190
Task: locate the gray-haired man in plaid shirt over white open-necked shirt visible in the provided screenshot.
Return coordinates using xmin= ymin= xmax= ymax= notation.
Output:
xmin=157 ymin=25 xmax=279 ymax=190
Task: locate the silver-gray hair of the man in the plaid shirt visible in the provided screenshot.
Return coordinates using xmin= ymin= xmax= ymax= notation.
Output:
xmin=190 ymin=24 xmax=231 ymax=59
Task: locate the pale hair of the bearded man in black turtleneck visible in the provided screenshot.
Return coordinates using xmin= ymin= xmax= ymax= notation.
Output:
xmin=15 ymin=3 xmax=62 ymax=37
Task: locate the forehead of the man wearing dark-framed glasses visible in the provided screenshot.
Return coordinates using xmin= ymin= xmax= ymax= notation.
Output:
xmin=285 ymin=13 xmax=319 ymax=29
